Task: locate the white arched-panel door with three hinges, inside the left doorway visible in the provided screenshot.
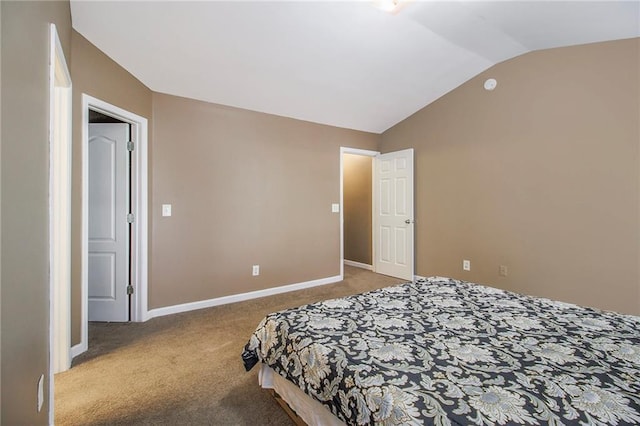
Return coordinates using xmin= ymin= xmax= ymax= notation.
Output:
xmin=88 ymin=123 xmax=129 ymax=321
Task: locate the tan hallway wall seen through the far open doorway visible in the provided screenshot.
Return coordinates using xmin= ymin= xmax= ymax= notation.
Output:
xmin=342 ymin=154 xmax=373 ymax=265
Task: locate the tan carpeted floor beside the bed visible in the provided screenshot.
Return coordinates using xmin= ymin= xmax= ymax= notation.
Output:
xmin=55 ymin=267 xmax=402 ymax=426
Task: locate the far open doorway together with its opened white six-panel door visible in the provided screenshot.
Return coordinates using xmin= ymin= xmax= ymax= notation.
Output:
xmin=340 ymin=147 xmax=415 ymax=280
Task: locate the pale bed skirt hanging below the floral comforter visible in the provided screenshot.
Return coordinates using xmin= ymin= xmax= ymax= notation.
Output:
xmin=258 ymin=364 xmax=345 ymax=426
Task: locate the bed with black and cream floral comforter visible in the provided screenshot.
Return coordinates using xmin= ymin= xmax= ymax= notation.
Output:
xmin=242 ymin=277 xmax=640 ymax=425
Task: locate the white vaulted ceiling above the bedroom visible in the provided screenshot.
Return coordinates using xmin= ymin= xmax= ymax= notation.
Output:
xmin=71 ymin=0 xmax=640 ymax=133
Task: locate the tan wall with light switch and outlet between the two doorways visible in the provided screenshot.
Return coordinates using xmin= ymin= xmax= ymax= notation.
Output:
xmin=149 ymin=93 xmax=379 ymax=308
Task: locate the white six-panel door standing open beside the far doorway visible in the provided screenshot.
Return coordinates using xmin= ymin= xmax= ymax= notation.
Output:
xmin=373 ymin=149 xmax=414 ymax=281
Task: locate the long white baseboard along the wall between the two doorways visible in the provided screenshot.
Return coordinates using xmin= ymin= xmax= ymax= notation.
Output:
xmin=147 ymin=275 xmax=342 ymax=319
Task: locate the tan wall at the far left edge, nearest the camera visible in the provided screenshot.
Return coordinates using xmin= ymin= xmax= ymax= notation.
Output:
xmin=0 ymin=1 xmax=71 ymax=425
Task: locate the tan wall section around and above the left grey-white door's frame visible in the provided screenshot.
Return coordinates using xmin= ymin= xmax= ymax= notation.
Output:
xmin=71 ymin=31 xmax=153 ymax=345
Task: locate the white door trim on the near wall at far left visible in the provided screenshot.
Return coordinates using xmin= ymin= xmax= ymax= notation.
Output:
xmin=47 ymin=24 xmax=72 ymax=424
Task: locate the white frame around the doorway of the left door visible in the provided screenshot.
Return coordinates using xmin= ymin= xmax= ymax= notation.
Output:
xmin=72 ymin=93 xmax=148 ymax=356
